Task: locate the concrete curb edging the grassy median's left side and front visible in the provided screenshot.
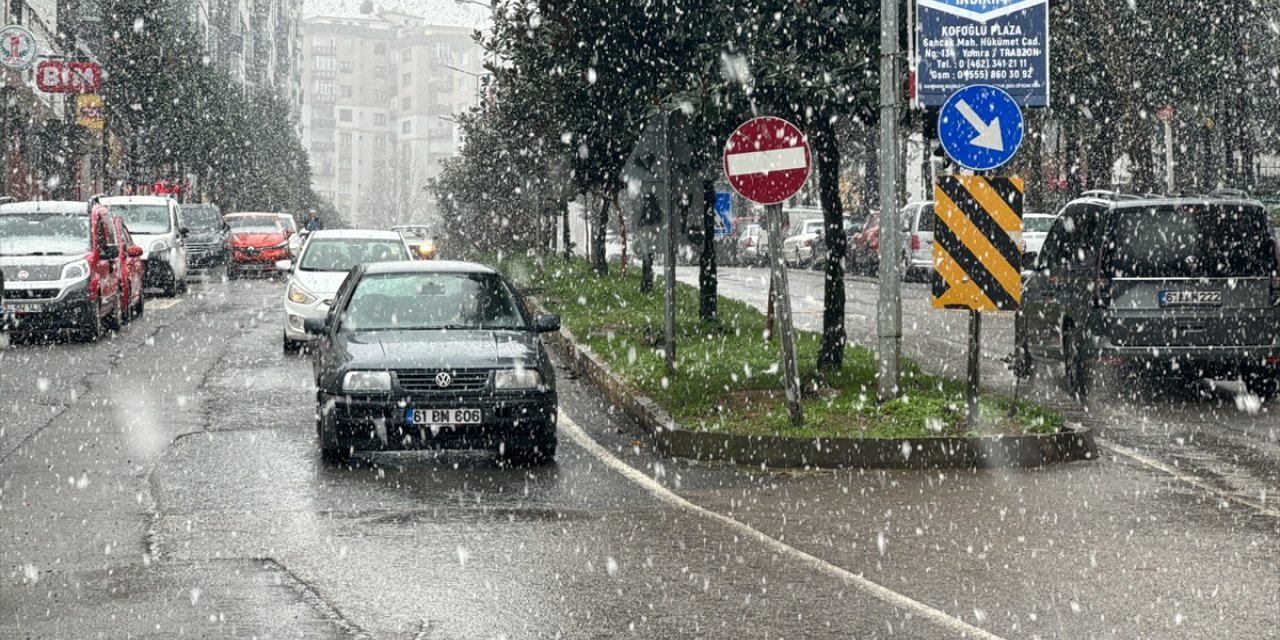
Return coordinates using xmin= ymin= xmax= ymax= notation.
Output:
xmin=536 ymin=299 xmax=1098 ymax=470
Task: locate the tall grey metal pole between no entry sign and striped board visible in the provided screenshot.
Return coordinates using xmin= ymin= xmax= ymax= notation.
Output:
xmin=876 ymin=0 xmax=902 ymax=402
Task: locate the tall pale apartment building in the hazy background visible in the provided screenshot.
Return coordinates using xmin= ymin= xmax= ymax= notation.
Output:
xmin=302 ymin=4 xmax=483 ymax=227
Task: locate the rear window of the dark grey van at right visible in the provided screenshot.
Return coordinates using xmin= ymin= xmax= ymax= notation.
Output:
xmin=1105 ymin=205 xmax=1276 ymax=278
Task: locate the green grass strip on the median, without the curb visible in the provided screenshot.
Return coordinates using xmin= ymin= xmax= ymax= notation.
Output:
xmin=489 ymin=259 xmax=1064 ymax=438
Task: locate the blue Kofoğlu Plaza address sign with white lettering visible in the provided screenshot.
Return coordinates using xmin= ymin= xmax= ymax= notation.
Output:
xmin=915 ymin=0 xmax=1050 ymax=106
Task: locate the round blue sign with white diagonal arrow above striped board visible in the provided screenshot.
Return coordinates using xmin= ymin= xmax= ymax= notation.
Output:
xmin=938 ymin=84 xmax=1023 ymax=172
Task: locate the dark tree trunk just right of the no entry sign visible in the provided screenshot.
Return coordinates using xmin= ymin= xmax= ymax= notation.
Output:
xmin=813 ymin=118 xmax=849 ymax=371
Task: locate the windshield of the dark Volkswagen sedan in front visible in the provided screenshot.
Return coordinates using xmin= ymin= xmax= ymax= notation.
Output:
xmin=343 ymin=273 xmax=526 ymax=332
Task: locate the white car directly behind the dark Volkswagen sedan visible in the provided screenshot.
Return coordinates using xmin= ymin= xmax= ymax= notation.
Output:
xmin=275 ymin=229 xmax=413 ymax=353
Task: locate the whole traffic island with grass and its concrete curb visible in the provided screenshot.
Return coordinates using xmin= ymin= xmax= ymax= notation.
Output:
xmin=500 ymin=260 xmax=1097 ymax=468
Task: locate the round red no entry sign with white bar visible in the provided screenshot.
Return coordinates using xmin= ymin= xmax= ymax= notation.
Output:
xmin=724 ymin=115 xmax=810 ymax=205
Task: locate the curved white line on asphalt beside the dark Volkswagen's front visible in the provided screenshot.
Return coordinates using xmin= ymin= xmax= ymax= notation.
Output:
xmin=559 ymin=411 xmax=1002 ymax=640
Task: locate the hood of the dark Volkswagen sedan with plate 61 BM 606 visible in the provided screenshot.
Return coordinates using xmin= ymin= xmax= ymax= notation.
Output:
xmin=347 ymin=330 xmax=538 ymax=370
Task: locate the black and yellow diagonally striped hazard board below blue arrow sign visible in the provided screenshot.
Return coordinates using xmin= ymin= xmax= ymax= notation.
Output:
xmin=933 ymin=175 xmax=1023 ymax=311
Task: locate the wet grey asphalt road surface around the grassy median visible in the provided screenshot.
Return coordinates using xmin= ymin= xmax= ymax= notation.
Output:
xmin=0 ymin=270 xmax=1280 ymax=639
